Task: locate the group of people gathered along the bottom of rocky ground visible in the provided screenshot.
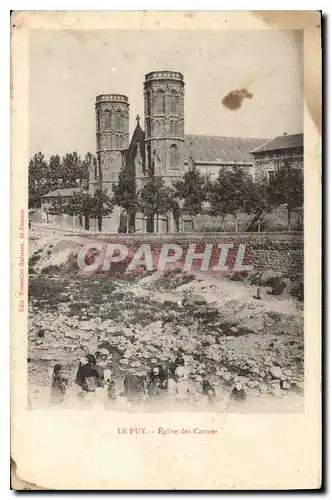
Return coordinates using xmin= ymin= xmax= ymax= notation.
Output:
xmin=51 ymin=352 xmax=246 ymax=405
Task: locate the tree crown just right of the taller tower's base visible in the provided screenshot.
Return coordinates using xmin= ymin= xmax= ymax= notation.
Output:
xmin=174 ymin=165 xmax=206 ymax=216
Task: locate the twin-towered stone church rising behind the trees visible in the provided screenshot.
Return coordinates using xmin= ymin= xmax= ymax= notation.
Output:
xmin=89 ymin=71 xmax=267 ymax=233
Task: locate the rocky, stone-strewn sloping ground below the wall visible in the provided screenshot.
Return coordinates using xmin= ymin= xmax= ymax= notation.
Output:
xmin=28 ymin=235 xmax=304 ymax=413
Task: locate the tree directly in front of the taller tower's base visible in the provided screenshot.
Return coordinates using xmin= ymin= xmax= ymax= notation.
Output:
xmin=139 ymin=176 xmax=177 ymax=233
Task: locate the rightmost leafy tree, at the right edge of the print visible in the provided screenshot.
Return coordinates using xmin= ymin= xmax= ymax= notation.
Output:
xmin=269 ymin=160 xmax=304 ymax=231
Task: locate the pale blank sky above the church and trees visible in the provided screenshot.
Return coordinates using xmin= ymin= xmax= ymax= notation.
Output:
xmin=29 ymin=30 xmax=303 ymax=157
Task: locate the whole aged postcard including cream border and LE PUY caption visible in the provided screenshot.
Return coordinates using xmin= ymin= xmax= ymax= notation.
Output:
xmin=11 ymin=11 xmax=321 ymax=490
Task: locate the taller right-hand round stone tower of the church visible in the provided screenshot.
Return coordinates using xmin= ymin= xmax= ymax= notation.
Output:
xmin=144 ymin=71 xmax=184 ymax=183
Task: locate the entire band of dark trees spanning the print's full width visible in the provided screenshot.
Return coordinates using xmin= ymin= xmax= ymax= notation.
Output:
xmin=29 ymin=152 xmax=303 ymax=232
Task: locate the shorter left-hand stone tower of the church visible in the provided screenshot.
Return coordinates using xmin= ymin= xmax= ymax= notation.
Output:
xmin=89 ymin=94 xmax=129 ymax=194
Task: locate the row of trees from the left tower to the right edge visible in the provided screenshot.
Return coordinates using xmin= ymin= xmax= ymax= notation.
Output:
xmin=113 ymin=161 xmax=303 ymax=232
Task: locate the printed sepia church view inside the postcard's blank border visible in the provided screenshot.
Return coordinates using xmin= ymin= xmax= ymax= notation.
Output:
xmin=27 ymin=26 xmax=304 ymax=412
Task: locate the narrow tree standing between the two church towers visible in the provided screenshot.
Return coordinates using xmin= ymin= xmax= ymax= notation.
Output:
xmin=113 ymin=168 xmax=138 ymax=230
